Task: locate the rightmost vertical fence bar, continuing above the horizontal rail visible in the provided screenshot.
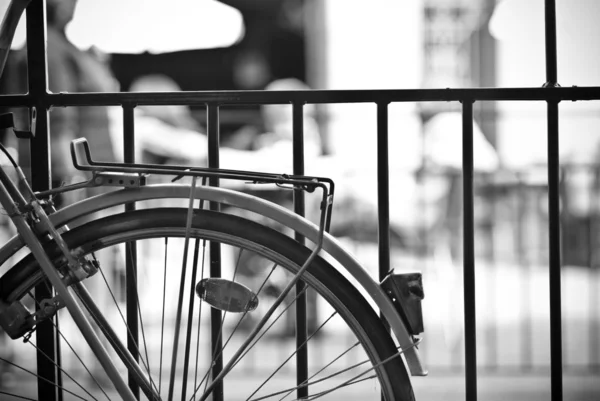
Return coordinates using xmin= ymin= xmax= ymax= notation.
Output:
xmin=545 ymin=0 xmax=563 ymax=401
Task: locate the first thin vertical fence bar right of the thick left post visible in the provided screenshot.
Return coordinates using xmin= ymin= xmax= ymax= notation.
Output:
xmin=123 ymin=104 xmax=140 ymax=400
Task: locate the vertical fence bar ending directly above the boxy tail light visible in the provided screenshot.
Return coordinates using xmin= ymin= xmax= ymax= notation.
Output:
xmin=377 ymin=103 xmax=391 ymax=281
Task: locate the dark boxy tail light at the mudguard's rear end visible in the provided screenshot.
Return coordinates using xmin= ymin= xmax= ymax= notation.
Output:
xmin=381 ymin=273 xmax=425 ymax=336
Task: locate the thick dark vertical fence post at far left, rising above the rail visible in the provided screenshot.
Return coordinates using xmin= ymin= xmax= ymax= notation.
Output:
xmin=26 ymin=1 xmax=62 ymax=401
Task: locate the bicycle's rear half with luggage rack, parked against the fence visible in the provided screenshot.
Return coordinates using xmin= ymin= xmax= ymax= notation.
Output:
xmin=0 ymin=0 xmax=426 ymax=400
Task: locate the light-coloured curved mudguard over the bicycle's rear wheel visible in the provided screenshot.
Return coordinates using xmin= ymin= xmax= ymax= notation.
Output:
xmin=0 ymin=184 xmax=427 ymax=376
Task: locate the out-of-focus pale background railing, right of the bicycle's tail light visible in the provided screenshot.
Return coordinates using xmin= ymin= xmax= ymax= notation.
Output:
xmin=410 ymin=165 xmax=600 ymax=374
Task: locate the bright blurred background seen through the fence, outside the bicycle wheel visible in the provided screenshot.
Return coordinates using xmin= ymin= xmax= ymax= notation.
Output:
xmin=2 ymin=0 xmax=600 ymax=400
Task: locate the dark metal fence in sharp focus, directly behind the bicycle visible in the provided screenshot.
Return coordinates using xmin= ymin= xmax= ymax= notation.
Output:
xmin=0 ymin=0 xmax=600 ymax=401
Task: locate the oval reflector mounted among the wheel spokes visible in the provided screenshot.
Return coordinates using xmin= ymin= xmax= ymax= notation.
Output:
xmin=196 ymin=278 xmax=258 ymax=313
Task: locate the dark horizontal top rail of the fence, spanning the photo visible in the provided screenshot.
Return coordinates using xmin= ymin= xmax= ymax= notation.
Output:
xmin=0 ymin=86 xmax=600 ymax=108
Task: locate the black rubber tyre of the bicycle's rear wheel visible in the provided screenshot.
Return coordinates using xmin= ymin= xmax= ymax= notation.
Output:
xmin=0 ymin=208 xmax=414 ymax=400
